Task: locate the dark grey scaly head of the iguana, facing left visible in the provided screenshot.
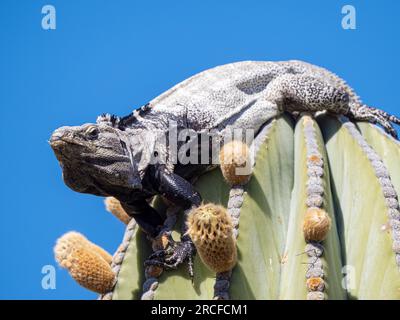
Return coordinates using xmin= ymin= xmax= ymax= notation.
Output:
xmin=49 ymin=122 xmax=148 ymax=196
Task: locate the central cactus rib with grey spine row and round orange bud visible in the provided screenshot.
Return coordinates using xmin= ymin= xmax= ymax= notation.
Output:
xmin=279 ymin=115 xmax=345 ymax=299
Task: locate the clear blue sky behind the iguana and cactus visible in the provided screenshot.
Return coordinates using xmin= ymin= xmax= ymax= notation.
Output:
xmin=0 ymin=0 xmax=400 ymax=299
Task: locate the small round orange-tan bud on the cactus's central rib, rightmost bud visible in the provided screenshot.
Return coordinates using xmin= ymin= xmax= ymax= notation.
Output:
xmin=303 ymin=208 xmax=331 ymax=242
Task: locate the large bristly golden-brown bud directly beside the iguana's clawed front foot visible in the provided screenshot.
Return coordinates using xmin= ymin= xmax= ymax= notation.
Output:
xmin=187 ymin=204 xmax=237 ymax=273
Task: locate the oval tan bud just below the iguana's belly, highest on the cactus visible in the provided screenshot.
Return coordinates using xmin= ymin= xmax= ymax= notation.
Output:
xmin=219 ymin=140 xmax=252 ymax=185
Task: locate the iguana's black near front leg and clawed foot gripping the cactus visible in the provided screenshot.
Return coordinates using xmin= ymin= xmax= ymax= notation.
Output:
xmin=145 ymin=167 xmax=201 ymax=278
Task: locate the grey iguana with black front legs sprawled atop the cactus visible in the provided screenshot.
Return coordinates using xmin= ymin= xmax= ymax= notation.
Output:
xmin=50 ymin=61 xmax=400 ymax=275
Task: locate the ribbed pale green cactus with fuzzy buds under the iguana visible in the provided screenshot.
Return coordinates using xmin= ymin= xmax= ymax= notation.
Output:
xmin=56 ymin=114 xmax=400 ymax=300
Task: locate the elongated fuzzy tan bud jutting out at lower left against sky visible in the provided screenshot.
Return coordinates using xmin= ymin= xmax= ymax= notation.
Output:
xmin=54 ymin=232 xmax=115 ymax=293
